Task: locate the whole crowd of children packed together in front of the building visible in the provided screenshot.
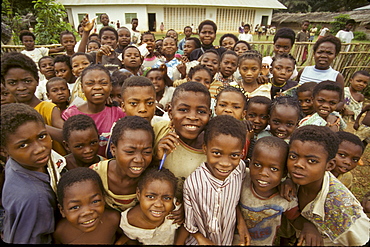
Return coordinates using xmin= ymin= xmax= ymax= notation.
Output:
xmin=0 ymin=14 xmax=370 ymax=246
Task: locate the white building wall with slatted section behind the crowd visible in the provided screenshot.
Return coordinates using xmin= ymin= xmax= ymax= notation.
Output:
xmin=66 ymin=5 xmax=272 ymax=32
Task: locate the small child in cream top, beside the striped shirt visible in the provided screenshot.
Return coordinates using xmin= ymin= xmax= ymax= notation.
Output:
xmin=120 ymin=166 xmax=180 ymax=245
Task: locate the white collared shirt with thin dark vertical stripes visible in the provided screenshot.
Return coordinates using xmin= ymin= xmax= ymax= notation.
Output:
xmin=184 ymin=160 xmax=246 ymax=245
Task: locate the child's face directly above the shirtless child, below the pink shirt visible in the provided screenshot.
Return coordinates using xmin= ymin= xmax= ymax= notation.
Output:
xmin=63 ymin=128 xmax=99 ymax=165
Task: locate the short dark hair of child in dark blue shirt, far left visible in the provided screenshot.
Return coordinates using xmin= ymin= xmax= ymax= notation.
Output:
xmin=0 ymin=103 xmax=45 ymax=147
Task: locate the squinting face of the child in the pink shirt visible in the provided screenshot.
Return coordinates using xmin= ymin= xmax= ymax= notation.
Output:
xmin=81 ymin=70 xmax=112 ymax=105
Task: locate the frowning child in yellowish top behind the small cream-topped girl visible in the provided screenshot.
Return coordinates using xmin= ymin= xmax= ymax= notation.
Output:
xmin=90 ymin=116 xmax=154 ymax=212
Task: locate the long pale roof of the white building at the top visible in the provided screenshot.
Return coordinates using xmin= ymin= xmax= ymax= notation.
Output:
xmin=58 ymin=0 xmax=286 ymax=9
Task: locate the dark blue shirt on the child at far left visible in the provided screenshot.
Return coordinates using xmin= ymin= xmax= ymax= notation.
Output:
xmin=2 ymin=158 xmax=57 ymax=244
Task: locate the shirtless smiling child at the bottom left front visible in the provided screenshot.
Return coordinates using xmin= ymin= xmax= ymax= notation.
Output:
xmin=53 ymin=167 xmax=122 ymax=244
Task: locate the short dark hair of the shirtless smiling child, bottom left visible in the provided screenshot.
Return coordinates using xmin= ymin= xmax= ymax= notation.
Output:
xmin=57 ymin=167 xmax=105 ymax=207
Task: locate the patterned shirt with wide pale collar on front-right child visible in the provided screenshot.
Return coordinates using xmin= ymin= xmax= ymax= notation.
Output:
xmin=301 ymin=171 xmax=370 ymax=246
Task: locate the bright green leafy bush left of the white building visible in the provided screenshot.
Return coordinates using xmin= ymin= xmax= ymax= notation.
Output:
xmin=33 ymin=0 xmax=77 ymax=45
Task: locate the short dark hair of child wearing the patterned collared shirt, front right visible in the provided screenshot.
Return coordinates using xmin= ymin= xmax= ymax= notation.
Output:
xmin=289 ymin=125 xmax=340 ymax=162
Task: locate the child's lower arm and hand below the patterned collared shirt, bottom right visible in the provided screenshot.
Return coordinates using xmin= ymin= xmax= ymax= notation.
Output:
xmin=291 ymin=215 xmax=324 ymax=246
